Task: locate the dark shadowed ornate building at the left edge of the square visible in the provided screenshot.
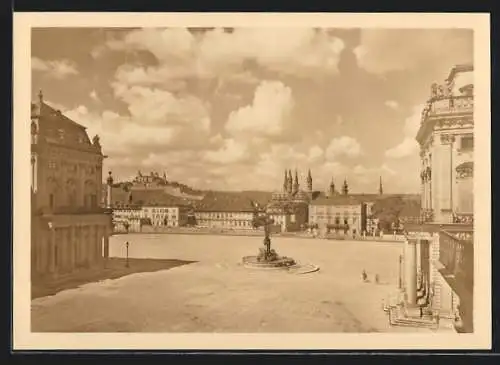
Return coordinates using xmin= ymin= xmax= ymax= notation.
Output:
xmin=31 ymin=92 xmax=112 ymax=275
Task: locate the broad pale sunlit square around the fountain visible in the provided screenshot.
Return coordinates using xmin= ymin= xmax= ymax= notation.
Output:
xmin=32 ymin=234 xmax=428 ymax=332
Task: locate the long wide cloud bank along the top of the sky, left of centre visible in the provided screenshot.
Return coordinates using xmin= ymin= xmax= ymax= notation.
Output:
xmin=102 ymin=28 xmax=344 ymax=84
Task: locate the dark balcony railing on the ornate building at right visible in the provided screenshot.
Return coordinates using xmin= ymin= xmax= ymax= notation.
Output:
xmin=439 ymin=230 xmax=474 ymax=288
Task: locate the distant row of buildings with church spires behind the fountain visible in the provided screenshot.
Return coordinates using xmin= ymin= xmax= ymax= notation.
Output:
xmin=112 ymin=170 xmax=390 ymax=235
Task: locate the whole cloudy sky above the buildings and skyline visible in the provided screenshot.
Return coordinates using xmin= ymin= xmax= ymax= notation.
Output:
xmin=32 ymin=28 xmax=472 ymax=193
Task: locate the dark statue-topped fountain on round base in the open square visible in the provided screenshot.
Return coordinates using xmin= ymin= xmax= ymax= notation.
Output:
xmin=243 ymin=206 xmax=319 ymax=272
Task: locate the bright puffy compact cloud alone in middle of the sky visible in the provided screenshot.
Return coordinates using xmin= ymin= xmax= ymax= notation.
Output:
xmin=225 ymin=81 xmax=293 ymax=136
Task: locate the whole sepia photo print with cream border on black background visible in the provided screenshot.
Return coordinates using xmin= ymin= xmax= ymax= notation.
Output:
xmin=13 ymin=13 xmax=491 ymax=349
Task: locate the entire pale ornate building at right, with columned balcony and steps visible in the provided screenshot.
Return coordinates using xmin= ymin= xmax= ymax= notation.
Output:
xmin=403 ymin=65 xmax=474 ymax=332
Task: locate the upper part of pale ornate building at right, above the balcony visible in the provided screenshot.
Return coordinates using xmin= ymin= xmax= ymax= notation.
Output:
xmin=416 ymin=65 xmax=474 ymax=223
